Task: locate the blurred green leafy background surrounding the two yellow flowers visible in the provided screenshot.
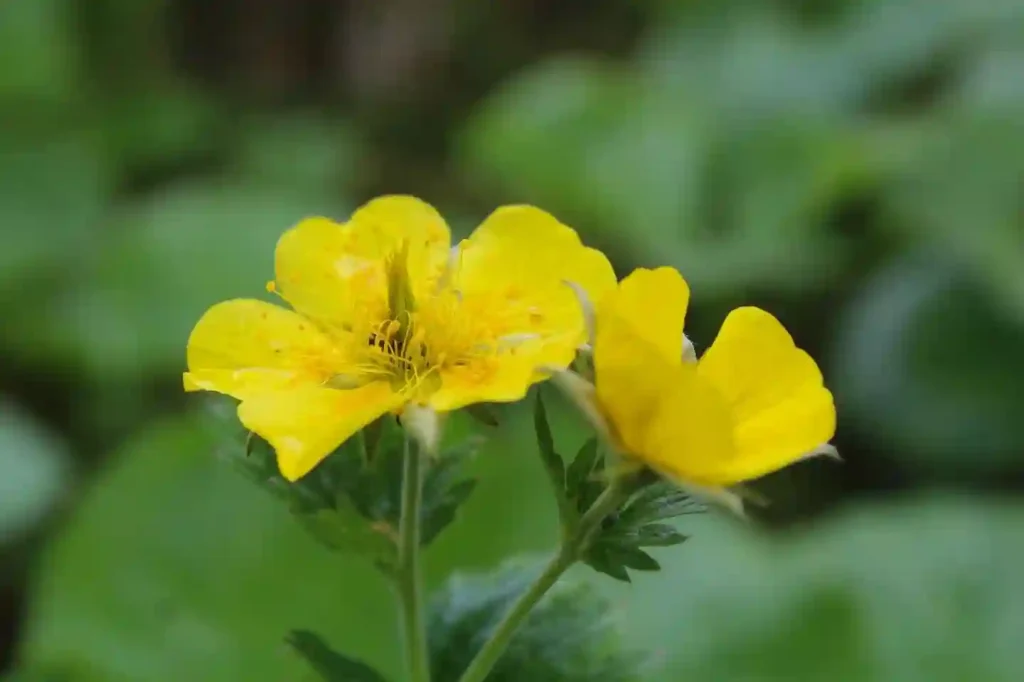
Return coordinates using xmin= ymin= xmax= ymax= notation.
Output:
xmin=0 ymin=0 xmax=1024 ymax=682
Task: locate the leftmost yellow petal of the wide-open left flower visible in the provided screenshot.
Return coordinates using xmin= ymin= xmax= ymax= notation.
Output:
xmin=184 ymin=299 xmax=346 ymax=399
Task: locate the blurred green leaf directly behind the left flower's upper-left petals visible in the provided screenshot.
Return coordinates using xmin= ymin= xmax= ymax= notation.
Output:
xmin=29 ymin=183 xmax=348 ymax=377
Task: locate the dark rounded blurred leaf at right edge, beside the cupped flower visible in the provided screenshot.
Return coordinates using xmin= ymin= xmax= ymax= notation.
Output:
xmin=833 ymin=253 xmax=1024 ymax=479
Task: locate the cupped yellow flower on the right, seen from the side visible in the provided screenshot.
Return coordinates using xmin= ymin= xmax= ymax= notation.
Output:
xmin=562 ymin=267 xmax=836 ymax=503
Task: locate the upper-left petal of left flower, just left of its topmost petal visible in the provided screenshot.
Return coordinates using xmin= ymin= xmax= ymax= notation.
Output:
xmin=274 ymin=218 xmax=387 ymax=330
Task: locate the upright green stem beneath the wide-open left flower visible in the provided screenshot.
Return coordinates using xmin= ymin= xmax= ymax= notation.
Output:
xmin=395 ymin=435 xmax=430 ymax=682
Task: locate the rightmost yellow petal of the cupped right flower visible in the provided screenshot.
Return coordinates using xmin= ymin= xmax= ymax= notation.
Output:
xmin=697 ymin=307 xmax=836 ymax=482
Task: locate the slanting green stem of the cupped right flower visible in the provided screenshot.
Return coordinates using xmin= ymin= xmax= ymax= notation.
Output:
xmin=459 ymin=479 xmax=623 ymax=682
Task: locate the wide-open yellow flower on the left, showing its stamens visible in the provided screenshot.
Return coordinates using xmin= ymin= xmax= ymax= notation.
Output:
xmin=184 ymin=196 xmax=615 ymax=480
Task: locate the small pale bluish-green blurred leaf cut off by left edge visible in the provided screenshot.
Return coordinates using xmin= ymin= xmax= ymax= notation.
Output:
xmin=0 ymin=399 xmax=68 ymax=547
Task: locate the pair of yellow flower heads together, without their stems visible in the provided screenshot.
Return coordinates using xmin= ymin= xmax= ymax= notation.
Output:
xmin=184 ymin=196 xmax=836 ymax=501
